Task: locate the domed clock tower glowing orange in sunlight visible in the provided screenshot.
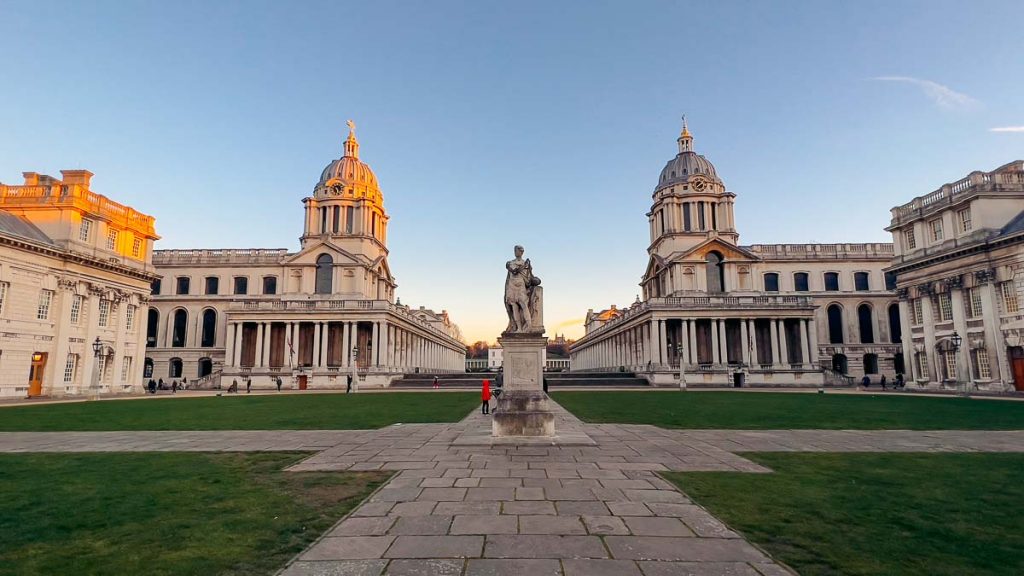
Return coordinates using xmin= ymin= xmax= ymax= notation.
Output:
xmin=301 ymin=120 xmax=388 ymax=259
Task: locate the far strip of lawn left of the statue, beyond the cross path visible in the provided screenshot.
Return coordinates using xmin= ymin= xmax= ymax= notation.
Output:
xmin=0 ymin=393 xmax=479 ymax=431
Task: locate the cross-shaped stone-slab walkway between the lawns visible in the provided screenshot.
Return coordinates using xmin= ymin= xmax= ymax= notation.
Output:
xmin=0 ymin=405 xmax=1024 ymax=576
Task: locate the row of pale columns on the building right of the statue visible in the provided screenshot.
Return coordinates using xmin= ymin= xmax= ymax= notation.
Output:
xmin=572 ymin=318 xmax=818 ymax=370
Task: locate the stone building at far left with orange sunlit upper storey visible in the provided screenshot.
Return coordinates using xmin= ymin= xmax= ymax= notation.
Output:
xmin=0 ymin=170 xmax=158 ymax=397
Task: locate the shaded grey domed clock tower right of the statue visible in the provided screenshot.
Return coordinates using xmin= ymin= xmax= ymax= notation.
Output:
xmin=647 ymin=116 xmax=739 ymax=258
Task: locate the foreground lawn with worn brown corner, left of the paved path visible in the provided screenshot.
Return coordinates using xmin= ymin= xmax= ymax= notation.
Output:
xmin=0 ymin=452 xmax=387 ymax=576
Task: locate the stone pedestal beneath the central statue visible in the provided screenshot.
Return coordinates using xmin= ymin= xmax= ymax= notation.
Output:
xmin=492 ymin=333 xmax=555 ymax=437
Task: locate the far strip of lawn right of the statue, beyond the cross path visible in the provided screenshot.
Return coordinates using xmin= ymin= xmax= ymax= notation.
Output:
xmin=552 ymin=390 xmax=1024 ymax=430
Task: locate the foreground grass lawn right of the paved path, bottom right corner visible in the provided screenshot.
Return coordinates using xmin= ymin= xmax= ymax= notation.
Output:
xmin=664 ymin=453 xmax=1024 ymax=576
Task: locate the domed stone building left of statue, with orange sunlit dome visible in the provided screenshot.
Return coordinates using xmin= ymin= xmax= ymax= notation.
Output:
xmin=146 ymin=123 xmax=466 ymax=389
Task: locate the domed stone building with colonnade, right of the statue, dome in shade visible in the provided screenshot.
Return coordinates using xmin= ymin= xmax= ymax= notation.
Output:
xmin=571 ymin=122 xmax=904 ymax=385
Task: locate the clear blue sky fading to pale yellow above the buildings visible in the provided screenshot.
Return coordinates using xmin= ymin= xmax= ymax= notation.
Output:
xmin=0 ymin=0 xmax=1024 ymax=341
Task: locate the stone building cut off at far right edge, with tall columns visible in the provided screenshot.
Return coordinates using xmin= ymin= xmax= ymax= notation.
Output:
xmin=886 ymin=160 xmax=1024 ymax=390
